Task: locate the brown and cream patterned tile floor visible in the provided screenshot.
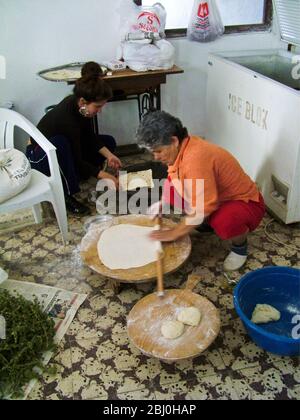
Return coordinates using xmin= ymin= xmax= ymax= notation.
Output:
xmin=0 ymin=155 xmax=300 ymax=400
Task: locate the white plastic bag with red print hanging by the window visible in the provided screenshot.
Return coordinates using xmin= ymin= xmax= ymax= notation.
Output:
xmin=187 ymin=0 xmax=225 ymax=42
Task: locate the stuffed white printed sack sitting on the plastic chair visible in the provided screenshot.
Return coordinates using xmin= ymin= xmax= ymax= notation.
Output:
xmin=0 ymin=149 xmax=31 ymax=203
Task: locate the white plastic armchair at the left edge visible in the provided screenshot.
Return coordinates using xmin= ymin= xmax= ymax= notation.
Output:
xmin=0 ymin=108 xmax=69 ymax=244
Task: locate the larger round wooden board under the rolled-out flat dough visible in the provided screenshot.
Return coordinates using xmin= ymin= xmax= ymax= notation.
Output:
xmin=81 ymin=215 xmax=192 ymax=283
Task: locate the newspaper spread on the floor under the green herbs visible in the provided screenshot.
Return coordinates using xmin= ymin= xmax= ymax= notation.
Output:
xmin=0 ymin=280 xmax=87 ymax=399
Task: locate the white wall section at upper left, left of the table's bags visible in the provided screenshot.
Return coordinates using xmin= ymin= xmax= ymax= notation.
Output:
xmin=0 ymin=0 xmax=122 ymax=149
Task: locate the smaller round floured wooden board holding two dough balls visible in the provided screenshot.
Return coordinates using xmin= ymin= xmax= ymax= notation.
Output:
xmin=127 ymin=289 xmax=220 ymax=361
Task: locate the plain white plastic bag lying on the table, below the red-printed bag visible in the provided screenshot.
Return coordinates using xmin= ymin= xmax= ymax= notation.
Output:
xmin=122 ymin=39 xmax=175 ymax=71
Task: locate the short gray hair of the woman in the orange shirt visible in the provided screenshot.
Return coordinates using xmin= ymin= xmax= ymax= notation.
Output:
xmin=136 ymin=111 xmax=188 ymax=149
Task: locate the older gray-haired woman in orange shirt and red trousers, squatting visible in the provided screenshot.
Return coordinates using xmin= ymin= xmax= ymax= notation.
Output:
xmin=137 ymin=111 xmax=265 ymax=271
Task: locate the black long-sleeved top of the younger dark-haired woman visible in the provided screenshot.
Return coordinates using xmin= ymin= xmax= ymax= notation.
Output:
xmin=37 ymin=95 xmax=104 ymax=177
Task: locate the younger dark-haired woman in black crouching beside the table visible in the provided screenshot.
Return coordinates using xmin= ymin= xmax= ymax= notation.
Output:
xmin=27 ymin=62 xmax=122 ymax=215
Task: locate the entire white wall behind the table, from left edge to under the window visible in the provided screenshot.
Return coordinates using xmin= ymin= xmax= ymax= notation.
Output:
xmin=0 ymin=0 xmax=280 ymax=151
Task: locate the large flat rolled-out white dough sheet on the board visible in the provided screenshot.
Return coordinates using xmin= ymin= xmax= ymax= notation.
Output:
xmin=97 ymin=224 xmax=162 ymax=270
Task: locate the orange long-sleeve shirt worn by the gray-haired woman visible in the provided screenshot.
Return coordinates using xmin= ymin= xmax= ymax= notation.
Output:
xmin=168 ymin=136 xmax=259 ymax=217
